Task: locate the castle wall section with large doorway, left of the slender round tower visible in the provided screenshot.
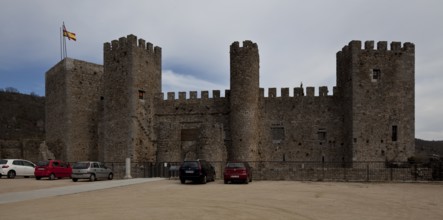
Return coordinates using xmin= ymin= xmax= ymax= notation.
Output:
xmin=155 ymin=91 xmax=229 ymax=162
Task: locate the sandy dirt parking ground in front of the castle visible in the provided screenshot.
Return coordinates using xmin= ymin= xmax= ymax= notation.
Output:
xmin=0 ymin=179 xmax=443 ymax=220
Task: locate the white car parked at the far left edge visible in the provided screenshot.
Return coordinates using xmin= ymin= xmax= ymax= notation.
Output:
xmin=0 ymin=159 xmax=35 ymax=179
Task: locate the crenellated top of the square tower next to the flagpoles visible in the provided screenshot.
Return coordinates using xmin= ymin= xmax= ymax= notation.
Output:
xmin=104 ymin=34 xmax=162 ymax=55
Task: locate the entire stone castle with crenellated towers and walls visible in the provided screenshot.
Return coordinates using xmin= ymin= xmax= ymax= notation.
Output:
xmin=46 ymin=35 xmax=415 ymax=166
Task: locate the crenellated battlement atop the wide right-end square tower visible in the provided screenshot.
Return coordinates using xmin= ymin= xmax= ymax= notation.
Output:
xmin=339 ymin=40 xmax=415 ymax=53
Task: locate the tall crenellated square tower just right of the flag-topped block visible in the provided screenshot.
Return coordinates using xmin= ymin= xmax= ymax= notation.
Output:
xmin=100 ymin=35 xmax=161 ymax=161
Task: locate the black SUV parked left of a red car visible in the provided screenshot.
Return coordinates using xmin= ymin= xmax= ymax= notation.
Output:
xmin=179 ymin=160 xmax=215 ymax=184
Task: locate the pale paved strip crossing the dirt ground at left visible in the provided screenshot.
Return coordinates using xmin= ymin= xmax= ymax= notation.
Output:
xmin=0 ymin=178 xmax=163 ymax=204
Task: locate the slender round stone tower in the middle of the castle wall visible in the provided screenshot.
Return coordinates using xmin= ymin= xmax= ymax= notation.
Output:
xmin=228 ymin=41 xmax=260 ymax=161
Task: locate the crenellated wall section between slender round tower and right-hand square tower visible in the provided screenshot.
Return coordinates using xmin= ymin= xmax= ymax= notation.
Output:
xmin=259 ymin=87 xmax=345 ymax=162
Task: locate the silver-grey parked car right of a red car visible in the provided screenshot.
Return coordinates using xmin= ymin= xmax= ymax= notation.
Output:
xmin=71 ymin=161 xmax=114 ymax=182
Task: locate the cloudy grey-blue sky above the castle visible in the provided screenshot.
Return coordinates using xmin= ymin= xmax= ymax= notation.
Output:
xmin=0 ymin=0 xmax=443 ymax=140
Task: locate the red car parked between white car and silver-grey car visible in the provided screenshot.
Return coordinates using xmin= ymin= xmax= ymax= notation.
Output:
xmin=34 ymin=160 xmax=72 ymax=180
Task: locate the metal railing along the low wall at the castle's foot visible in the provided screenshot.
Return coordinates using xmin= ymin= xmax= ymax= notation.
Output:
xmin=105 ymin=161 xmax=443 ymax=182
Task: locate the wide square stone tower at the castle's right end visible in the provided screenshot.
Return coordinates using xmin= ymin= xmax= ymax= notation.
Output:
xmin=337 ymin=41 xmax=415 ymax=161
